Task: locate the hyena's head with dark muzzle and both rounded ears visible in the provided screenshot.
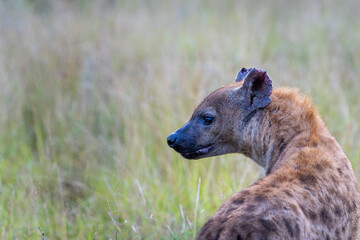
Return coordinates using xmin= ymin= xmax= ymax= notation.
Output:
xmin=167 ymin=68 xmax=272 ymax=159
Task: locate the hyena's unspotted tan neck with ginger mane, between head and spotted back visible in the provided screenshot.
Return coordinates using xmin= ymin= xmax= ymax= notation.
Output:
xmin=242 ymin=89 xmax=323 ymax=175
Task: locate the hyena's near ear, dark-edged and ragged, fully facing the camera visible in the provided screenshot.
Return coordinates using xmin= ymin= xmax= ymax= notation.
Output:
xmin=243 ymin=68 xmax=272 ymax=108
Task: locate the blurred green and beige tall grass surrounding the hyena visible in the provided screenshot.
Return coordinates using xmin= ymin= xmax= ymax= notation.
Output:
xmin=0 ymin=0 xmax=360 ymax=239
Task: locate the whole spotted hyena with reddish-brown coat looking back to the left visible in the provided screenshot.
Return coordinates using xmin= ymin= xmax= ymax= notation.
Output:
xmin=167 ymin=68 xmax=359 ymax=240
